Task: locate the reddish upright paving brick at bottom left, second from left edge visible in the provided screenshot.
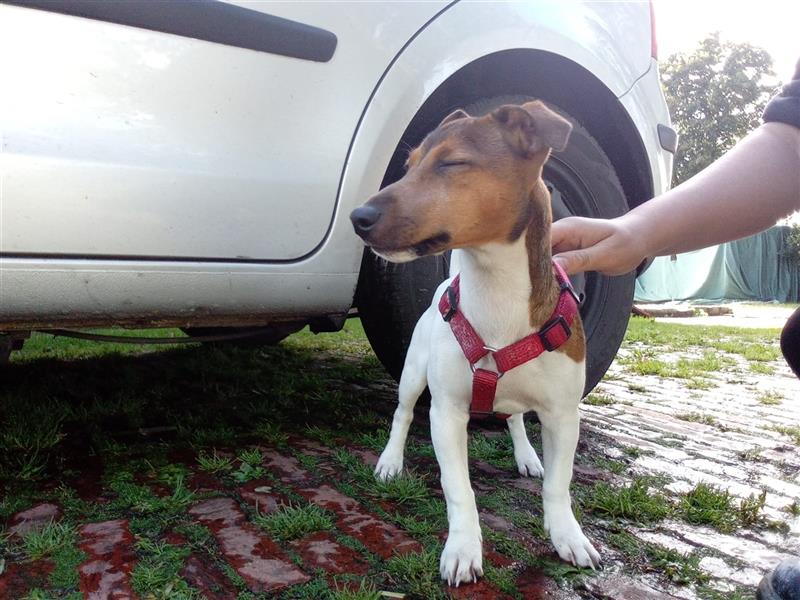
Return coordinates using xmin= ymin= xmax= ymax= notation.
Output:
xmin=78 ymin=519 xmax=136 ymax=600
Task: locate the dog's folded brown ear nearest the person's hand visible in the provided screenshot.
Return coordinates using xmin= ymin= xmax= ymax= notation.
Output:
xmin=491 ymin=100 xmax=572 ymax=157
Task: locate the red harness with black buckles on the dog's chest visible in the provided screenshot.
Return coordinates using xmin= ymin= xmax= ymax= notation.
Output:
xmin=439 ymin=263 xmax=580 ymax=419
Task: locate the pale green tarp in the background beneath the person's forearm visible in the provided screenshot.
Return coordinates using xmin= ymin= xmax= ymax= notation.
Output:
xmin=635 ymin=226 xmax=800 ymax=302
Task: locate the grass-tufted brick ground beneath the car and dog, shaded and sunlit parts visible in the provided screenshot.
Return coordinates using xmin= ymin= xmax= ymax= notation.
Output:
xmin=0 ymin=319 xmax=800 ymax=600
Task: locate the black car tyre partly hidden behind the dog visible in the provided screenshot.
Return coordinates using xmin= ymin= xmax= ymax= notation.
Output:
xmin=356 ymin=96 xmax=635 ymax=393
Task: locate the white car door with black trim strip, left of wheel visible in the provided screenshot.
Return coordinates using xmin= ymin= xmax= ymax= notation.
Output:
xmin=0 ymin=0 xmax=446 ymax=262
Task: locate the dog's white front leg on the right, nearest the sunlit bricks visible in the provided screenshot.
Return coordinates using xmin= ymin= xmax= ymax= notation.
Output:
xmin=539 ymin=407 xmax=600 ymax=568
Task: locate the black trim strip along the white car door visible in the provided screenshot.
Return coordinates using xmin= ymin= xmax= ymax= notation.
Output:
xmin=0 ymin=0 xmax=337 ymax=62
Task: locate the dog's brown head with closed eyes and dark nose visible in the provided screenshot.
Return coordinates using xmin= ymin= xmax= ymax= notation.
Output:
xmin=350 ymin=101 xmax=572 ymax=262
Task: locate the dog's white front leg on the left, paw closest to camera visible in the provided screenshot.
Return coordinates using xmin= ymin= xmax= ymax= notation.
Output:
xmin=431 ymin=400 xmax=483 ymax=586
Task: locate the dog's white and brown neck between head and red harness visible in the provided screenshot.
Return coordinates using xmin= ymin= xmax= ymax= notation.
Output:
xmin=459 ymin=180 xmax=559 ymax=346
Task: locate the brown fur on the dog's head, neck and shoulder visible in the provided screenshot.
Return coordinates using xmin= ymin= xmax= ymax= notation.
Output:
xmin=365 ymin=101 xmax=586 ymax=362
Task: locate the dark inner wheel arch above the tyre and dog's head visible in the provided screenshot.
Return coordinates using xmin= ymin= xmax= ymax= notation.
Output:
xmin=381 ymin=48 xmax=654 ymax=208
